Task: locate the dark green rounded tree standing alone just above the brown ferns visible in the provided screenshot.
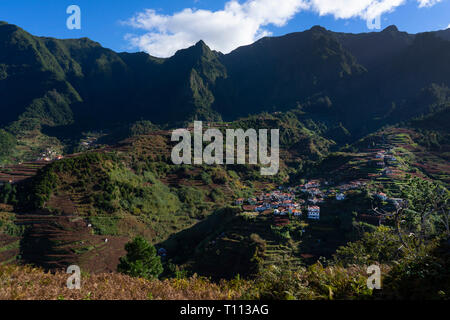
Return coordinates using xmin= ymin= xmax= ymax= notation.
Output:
xmin=117 ymin=236 xmax=163 ymax=279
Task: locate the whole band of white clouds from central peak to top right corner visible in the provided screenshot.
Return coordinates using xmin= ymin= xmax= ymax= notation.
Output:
xmin=123 ymin=0 xmax=442 ymax=57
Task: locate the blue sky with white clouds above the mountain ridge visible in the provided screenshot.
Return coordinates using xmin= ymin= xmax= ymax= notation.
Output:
xmin=0 ymin=0 xmax=450 ymax=57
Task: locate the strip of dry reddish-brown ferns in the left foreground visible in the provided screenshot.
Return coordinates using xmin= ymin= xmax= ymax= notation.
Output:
xmin=0 ymin=265 xmax=245 ymax=300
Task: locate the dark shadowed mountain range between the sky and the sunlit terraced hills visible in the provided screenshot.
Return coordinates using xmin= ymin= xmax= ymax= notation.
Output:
xmin=0 ymin=22 xmax=450 ymax=134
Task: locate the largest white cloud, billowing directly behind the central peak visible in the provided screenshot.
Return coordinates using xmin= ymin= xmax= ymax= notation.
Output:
xmin=126 ymin=0 xmax=306 ymax=57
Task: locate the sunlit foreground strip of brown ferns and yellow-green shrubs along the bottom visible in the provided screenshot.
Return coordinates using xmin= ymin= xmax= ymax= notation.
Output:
xmin=0 ymin=263 xmax=384 ymax=300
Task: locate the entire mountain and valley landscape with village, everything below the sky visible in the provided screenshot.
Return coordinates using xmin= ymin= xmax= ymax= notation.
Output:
xmin=0 ymin=22 xmax=450 ymax=299
